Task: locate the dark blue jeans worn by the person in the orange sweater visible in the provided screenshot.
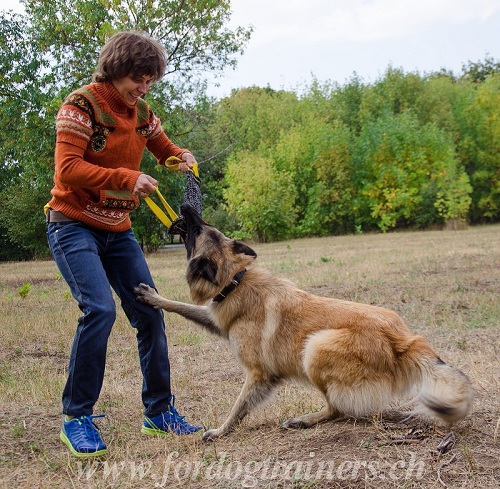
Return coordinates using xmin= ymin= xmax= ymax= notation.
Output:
xmin=47 ymin=221 xmax=171 ymax=417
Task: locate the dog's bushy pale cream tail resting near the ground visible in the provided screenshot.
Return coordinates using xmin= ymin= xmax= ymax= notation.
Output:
xmin=414 ymin=355 xmax=473 ymax=427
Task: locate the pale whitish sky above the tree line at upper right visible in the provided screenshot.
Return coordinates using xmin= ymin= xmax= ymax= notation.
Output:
xmin=0 ymin=0 xmax=500 ymax=97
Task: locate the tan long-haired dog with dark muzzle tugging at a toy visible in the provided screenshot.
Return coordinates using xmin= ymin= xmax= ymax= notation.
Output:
xmin=135 ymin=204 xmax=473 ymax=441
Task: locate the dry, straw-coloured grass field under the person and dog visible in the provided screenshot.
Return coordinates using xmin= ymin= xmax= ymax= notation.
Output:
xmin=0 ymin=225 xmax=500 ymax=489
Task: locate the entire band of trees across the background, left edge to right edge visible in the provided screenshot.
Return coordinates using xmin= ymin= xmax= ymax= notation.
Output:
xmin=0 ymin=0 xmax=500 ymax=260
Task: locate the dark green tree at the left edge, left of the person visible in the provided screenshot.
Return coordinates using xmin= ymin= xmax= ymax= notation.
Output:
xmin=0 ymin=12 xmax=55 ymax=260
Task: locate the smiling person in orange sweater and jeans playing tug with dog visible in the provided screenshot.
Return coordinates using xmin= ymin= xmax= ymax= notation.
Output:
xmin=46 ymin=32 xmax=201 ymax=457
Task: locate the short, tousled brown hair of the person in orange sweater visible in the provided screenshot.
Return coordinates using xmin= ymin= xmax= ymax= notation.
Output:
xmin=92 ymin=31 xmax=167 ymax=82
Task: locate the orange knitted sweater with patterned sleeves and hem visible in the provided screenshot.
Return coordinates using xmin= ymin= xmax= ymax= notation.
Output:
xmin=48 ymin=83 xmax=188 ymax=232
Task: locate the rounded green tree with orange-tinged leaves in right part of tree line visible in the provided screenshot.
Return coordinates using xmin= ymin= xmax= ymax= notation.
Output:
xmin=354 ymin=112 xmax=471 ymax=231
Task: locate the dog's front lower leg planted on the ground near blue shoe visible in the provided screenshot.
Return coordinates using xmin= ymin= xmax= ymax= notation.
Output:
xmin=202 ymin=374 xmax=280 ymax=441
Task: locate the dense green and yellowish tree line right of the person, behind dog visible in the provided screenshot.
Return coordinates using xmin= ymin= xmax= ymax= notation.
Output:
xmin=203 ymin=65 xmax=500 ymax=241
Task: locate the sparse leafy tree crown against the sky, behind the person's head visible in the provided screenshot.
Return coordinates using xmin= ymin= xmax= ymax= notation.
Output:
xmin=24 ymin=0 xmax=252 ymax=99
